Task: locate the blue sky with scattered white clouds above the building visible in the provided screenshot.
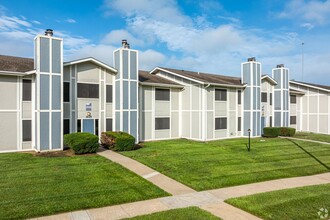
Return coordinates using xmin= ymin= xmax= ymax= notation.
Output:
xmin=0 ymin=0 xmax=330 ymax=85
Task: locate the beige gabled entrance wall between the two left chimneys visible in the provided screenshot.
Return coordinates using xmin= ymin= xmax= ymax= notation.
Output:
xmin=64 ymin=62 xmax=115 ymax=136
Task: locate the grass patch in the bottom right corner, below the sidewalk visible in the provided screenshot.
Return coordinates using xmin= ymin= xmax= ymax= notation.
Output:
xmin=226 ymin=184 xmax=330 ymax=220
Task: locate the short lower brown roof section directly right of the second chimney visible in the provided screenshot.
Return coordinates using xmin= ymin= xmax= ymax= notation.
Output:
xmin=139 ymin=70 xmax=183 ymax=87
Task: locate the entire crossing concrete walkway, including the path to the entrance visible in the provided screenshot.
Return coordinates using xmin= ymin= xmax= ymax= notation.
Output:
xmin=32 ymin=150 xmax=330 ymax=220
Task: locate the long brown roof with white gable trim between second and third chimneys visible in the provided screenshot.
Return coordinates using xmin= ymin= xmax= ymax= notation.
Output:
xmin=152 ymin=67 xmax=244 ymax=87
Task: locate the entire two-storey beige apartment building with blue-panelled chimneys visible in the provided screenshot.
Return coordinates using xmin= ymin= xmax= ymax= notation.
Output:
xmin=0 ymin=30 xmax=330 ymax=152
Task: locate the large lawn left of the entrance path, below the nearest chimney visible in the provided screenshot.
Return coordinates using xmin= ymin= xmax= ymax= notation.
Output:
xmin=0 ymin=153 xmax=168 ymax=219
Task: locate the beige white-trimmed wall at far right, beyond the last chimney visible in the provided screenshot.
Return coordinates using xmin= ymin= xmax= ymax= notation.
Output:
xmin=290 ymin=83 xmax=330 ymax=134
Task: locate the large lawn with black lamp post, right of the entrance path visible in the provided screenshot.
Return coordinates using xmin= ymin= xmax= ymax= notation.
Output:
xmin=122 ymin=138 xmax=330 ymax=190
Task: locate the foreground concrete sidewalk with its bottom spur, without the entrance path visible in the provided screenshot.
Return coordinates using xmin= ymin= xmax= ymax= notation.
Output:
xmin=37 ymin=173 xmax=330 ymax=220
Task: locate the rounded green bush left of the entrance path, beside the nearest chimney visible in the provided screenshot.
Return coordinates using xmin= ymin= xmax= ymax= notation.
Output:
xmin=64 ymin=132 xmax=99 ymax=154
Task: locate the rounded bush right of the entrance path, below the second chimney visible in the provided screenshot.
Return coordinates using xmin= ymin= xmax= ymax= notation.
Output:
xmin=101 ymin=131 xmax=135 ymax=151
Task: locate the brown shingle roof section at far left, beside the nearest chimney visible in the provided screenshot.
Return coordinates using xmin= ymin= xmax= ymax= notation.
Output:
xmin=0 ymin=55 xmax=34 ymax=73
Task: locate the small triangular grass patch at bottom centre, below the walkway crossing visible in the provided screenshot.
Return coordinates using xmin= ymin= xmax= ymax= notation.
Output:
xmin=125 ymin=207 xmax=220 ymax=220
